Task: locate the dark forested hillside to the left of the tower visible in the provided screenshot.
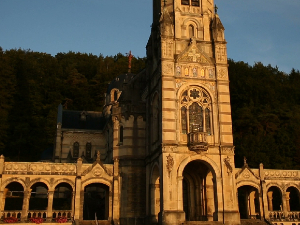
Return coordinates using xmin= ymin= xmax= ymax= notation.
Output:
xmin=0 ymin=47 xmax=145 ymax=161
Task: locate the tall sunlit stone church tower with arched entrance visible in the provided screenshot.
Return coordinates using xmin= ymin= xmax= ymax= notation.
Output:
xmin=143 ymin=0 xmax=240 ymax=224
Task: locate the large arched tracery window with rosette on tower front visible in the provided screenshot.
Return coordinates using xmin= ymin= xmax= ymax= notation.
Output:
xmin=180 ymin=86 xmax=212 ymax=135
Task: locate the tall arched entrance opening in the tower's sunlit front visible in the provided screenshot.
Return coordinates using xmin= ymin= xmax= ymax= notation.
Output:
xmin=182 ymin=160 xmax=218 ymax=221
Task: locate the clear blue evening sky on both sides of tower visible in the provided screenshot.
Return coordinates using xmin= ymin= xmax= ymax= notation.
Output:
xmin=0 ymin=0 xmax=300 ymax=73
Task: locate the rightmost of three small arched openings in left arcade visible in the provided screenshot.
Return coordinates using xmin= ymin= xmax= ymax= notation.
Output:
xmin=52 ymin=183 xmax=72 ymax=211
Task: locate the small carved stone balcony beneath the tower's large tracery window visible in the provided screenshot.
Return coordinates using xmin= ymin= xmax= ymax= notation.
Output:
xmin=188 ymin=132 xmax=208 ymax=152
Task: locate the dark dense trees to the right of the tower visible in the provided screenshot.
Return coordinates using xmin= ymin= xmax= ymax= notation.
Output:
xmin=229 ymin=60 xmax=300 ymax=169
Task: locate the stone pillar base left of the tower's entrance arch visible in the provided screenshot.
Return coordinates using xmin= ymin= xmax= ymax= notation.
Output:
xmin=158 ymin=210 xmax=185 ymax=225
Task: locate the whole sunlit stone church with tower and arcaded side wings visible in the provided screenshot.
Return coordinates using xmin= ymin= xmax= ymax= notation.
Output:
xmin=0 ymin=0 xmax=300 ymax=225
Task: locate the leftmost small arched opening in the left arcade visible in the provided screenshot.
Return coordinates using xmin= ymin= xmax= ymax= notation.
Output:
xmin=4 ymin=182 xmax=24 ymax=214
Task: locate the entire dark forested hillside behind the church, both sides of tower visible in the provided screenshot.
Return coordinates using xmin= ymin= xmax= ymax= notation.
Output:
xmin=0 ymin=48 xmax=300 ymax=169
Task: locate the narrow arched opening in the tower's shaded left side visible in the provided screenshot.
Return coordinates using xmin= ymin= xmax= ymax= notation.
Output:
xmin=150 ymin=166 xmax=160 ymax=223
